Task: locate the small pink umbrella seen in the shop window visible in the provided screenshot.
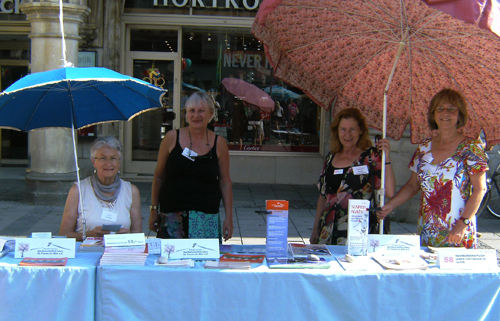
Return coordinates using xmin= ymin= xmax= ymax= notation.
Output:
xmin=222 ymin=78 xmax=275 ymax=113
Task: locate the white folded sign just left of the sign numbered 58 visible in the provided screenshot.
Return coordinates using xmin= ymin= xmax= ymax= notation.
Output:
xmin=368 ymin=234 xmax=420 ymax=254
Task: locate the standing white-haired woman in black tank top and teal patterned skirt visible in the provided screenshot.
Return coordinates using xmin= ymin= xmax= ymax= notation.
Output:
xmin=149 ymin=92 xmax=233 ymax=242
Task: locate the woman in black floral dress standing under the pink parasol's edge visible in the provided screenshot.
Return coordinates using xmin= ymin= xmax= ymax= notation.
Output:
xmin=309 ymin=108 xmax=396 ymax=245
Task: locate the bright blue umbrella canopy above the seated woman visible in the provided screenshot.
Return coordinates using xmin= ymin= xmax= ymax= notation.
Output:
xmin=0 ymin=67 xmax=165 ymax=131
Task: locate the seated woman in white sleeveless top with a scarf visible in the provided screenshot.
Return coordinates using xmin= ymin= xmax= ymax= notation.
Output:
xmin=59 ymin=136 xmax=142 ymax=240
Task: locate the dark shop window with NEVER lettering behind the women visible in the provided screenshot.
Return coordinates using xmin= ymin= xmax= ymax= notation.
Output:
xmin=181 ymin=27 xmax=320 ymax=152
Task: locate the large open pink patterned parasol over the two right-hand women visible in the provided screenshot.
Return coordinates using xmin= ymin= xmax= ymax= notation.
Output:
xmin=252 ymin=0 xmax=500 ymax=145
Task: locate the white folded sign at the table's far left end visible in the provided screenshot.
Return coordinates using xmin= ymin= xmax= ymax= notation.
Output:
xmin=14 ymin=238 xmax=76 ymax=259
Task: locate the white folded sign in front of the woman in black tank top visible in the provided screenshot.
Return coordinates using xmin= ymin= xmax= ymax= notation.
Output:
xmin=161 ymin=239 xmax=220 ymax=260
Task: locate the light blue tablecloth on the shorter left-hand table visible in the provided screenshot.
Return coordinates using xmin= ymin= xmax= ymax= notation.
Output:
xmin=0 ymin=252 xmax=102 ymax=321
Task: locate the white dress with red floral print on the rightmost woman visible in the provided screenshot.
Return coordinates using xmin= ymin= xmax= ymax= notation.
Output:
xmin=409 ymin=138 xmax=488 ymax=248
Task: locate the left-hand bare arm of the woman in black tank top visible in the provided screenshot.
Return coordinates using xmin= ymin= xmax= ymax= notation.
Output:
xmin=149 ymin=130 xmax=177 ymax=232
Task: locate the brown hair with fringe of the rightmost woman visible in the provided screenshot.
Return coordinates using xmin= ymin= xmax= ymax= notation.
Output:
xmin=427 ymin=88 xmax=469 ymax=129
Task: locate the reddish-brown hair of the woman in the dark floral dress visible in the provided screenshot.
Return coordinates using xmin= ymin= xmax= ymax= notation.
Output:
xmin=330 ymin=108 xmax=372 ymax=154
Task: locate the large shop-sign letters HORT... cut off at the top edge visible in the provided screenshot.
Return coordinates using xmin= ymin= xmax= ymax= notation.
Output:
xmin=153 ymin=0 xmax=260 ymax=10
